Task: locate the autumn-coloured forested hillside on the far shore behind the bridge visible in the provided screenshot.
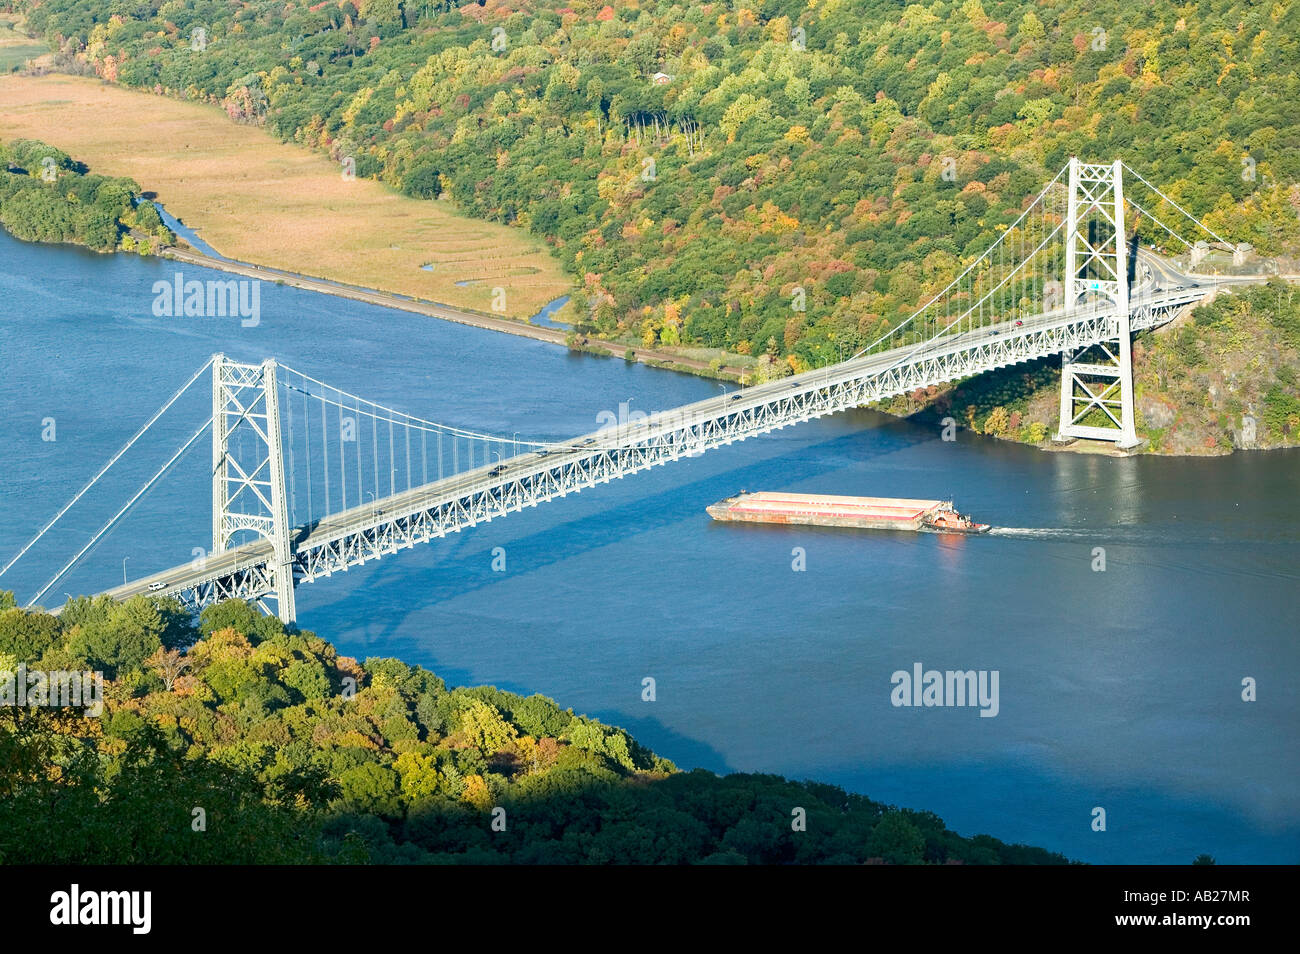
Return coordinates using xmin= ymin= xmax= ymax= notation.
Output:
xmin=10 ymin=0 xmax=1300 ymax=447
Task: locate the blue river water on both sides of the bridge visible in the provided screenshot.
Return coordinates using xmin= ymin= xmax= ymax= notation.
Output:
xmin=0 ymin=235 xmax=1300 ymax=863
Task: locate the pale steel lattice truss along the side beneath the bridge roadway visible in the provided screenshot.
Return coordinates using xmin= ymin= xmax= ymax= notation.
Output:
xmin=157 ymin=289 xmax=1208 ymax=610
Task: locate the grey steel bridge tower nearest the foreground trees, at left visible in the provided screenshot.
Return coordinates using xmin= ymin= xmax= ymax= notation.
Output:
xmin=212 ymin=355 xmax=295 ymax=623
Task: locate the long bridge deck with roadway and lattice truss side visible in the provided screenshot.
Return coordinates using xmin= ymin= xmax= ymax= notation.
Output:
xmin=76 ymin=265 xmax=1260 ymax=610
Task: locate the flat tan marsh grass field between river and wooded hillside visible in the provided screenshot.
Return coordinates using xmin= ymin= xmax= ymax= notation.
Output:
xmin=0 ymin=74 xmax=572 ymax=318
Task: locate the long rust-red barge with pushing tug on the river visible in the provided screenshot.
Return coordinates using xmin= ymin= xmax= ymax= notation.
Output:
xmin=706 ymin=490 xmax=989 ymax=533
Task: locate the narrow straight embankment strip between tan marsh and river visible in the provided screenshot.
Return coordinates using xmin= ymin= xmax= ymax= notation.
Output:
xmin=160 ymin=246 xmax=745 ymax=381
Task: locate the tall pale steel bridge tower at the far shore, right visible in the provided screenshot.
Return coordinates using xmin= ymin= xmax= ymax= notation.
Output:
xmin=1056 ymin=157 xmax=1139 ymax=448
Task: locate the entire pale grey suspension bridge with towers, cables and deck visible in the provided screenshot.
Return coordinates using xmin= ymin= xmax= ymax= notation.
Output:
xmin=0 ymin=159 xmax=1264 ymax=623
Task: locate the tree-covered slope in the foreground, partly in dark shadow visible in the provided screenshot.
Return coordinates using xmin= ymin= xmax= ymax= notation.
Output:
xmin=0 ymin=593 xmax=1066 ymax=864
